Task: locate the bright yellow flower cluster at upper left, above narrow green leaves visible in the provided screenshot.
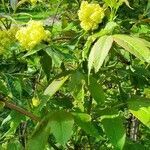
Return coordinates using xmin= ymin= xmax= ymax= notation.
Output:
xmin=16 ymin=20 xmax=49 ymax=49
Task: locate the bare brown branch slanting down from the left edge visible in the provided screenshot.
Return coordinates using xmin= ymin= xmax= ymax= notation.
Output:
xmin=0 ymin=99 xmax=41 ymax=122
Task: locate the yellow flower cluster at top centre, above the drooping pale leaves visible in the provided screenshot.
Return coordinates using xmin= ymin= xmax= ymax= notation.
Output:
xmin=78 ymin=1 xmax=104 ymax=31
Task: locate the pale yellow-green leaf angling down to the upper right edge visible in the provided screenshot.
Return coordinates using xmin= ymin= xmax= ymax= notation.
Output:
xmin=113 ymin=34 xmax=150 ymax=63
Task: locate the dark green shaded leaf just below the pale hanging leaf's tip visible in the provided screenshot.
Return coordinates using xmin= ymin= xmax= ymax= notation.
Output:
xmin=88 ymin=77 xmax=106 ymax=104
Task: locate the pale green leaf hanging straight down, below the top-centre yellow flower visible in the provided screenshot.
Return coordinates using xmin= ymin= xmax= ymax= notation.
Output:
xmin=88 ymin=36 xmax=113 ymax=74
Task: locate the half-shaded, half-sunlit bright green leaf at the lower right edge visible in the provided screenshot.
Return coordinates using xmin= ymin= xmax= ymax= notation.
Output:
xmin=128 ymin=97 xmax=150 ymax=128
